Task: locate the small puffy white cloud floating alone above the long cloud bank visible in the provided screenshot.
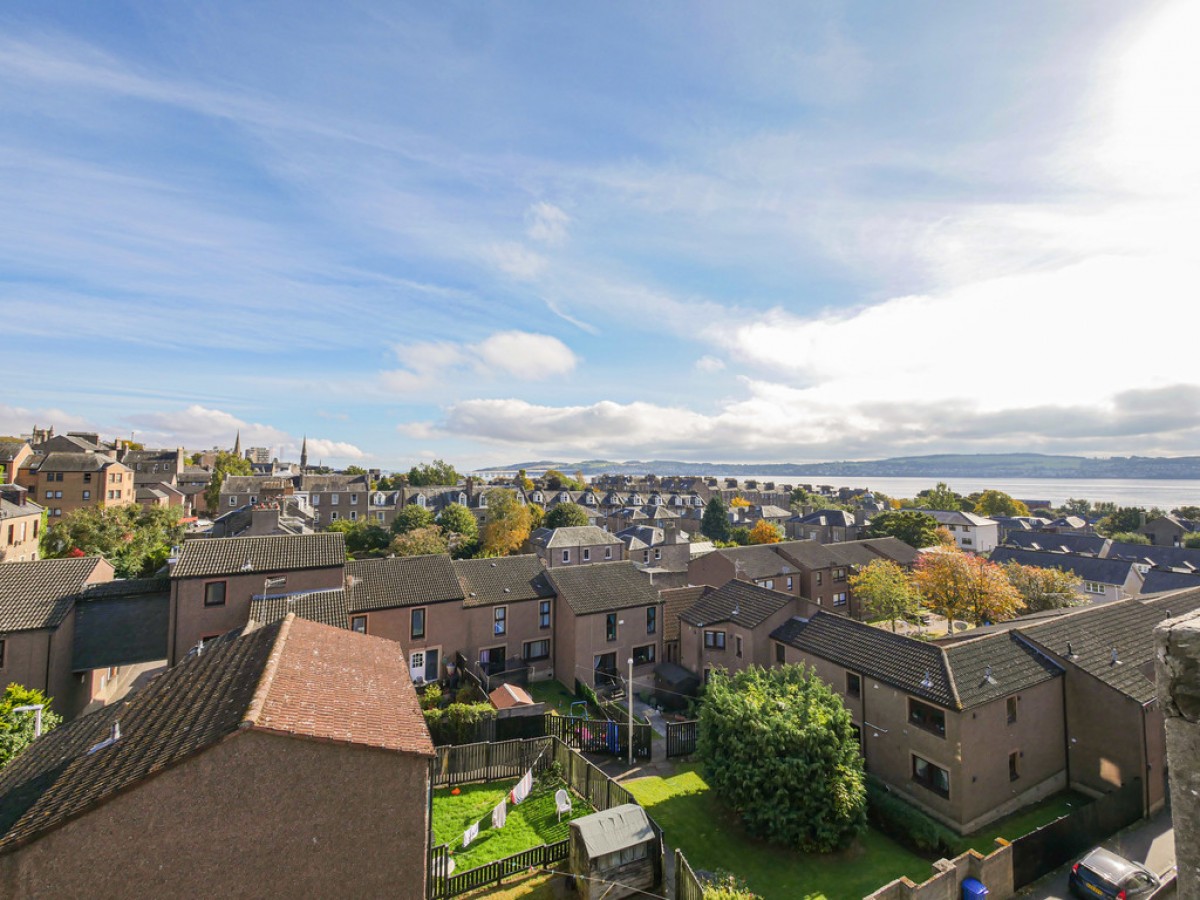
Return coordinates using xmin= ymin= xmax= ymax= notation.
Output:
xmin=380 ymin=331 xmax=577 ymax=394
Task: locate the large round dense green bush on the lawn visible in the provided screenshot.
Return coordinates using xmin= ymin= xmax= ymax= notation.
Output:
xmin=697 ymin=665 xmax=866 ymax=852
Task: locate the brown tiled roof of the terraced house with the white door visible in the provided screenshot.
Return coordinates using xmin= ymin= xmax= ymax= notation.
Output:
xmin=346 ymin=553 xmax=466 ymax=612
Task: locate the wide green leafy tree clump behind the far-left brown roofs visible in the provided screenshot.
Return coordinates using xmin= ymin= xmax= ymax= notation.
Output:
xmin=41 ymin=504 xmax=184 ymax=578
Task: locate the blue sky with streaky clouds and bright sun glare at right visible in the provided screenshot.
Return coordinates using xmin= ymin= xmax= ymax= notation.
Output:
xmin=0 ymin=1 xmax=1200 ymax=468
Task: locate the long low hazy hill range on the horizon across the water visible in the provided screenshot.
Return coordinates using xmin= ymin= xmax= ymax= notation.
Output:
xmin=478 ymin=454 xmax=1200 ymax=479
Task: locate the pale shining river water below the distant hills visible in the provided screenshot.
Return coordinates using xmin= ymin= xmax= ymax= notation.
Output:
xmin=720 ymin=475 xmax=1200 ymax=511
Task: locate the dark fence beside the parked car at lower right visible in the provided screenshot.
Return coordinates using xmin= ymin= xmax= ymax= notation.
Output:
xmin=1013 ymin=778 xmax=1142 ymax=888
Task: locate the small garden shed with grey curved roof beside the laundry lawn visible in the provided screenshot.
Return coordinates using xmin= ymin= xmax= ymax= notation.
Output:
xmin=570 ymin=803 xmax=662 ymax=900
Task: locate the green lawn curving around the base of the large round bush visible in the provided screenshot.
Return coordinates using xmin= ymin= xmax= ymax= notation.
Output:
xmin=624 ymin=764 xmax=932 ymax=900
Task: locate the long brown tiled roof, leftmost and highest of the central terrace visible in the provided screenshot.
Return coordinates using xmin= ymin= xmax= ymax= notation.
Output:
xmin=170 ymin=532 xmax=346 ymax=578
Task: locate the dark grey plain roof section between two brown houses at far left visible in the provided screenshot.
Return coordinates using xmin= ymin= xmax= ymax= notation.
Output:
xmin=71 ymin=578 xmax=170 ymax=672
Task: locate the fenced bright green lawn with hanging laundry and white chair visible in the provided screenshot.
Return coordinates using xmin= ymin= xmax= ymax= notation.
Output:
xmin=433 ymin=776 xmax=592 ymax=871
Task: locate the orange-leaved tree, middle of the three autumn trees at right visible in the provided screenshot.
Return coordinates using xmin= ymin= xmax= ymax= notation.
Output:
xmin=913 ymin=546 xmax=1025 ymax=634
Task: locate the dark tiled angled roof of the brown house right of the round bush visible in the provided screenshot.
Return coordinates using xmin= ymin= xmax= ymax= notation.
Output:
xmin=772 ymin=611 xmax=1062 ymax=710
